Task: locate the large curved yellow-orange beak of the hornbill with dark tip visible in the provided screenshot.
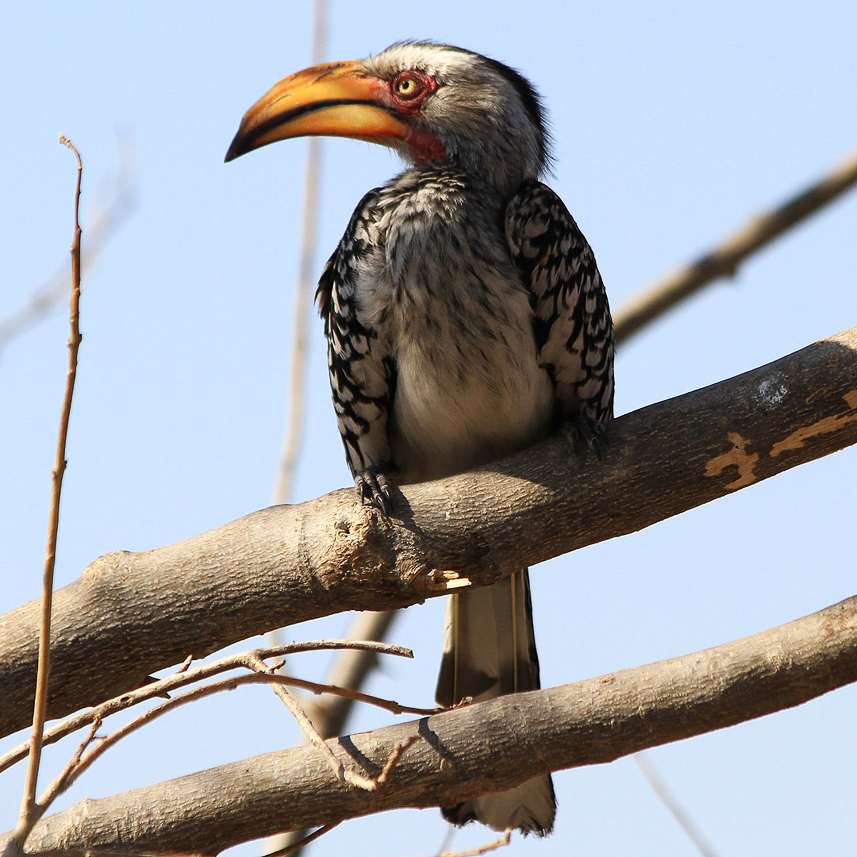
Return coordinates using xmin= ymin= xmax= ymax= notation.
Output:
xmin=226 ymin=62 xmax=410 ymax=161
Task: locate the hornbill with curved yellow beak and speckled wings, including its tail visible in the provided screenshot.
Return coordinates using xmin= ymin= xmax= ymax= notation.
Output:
xmin=226 ymin=41 xmax=614 ymax=836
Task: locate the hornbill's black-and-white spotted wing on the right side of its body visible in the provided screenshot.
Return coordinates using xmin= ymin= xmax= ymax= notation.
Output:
xmin=506 ymin=179 xmax=613 ymax=423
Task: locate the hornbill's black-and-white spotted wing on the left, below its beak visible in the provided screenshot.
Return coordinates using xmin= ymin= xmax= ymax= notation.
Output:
xmin=316 ymin=191 xmax=396 ymax=498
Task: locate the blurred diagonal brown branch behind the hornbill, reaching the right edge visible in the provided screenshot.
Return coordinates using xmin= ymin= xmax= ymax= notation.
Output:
xmin=615 ymin=144 xmax=857 ymax=341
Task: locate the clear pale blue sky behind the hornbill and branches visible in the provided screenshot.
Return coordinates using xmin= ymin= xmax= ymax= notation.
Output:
xmin=0 ymin=0 xmax=857 ymax=857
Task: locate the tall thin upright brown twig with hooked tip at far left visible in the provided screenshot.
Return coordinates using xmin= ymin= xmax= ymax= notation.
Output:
xmin=6 ymin=134 xmax=83 ymax=849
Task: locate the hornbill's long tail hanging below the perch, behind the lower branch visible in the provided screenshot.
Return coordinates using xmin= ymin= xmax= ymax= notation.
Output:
xmin=437 ymin=569 xmax=556 ymax=836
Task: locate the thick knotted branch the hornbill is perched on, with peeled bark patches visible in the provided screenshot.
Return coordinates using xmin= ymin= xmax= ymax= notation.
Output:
xmin=0 ymin=328 xmax=857 ymax=734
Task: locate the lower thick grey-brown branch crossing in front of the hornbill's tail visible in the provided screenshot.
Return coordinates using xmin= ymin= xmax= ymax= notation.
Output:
xmin=0 ymin=597 xmax=857 ymax=855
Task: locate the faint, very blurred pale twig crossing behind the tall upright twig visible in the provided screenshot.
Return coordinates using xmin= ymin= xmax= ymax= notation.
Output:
xmin=0 ymin=140 xmax=136 ymax=353
